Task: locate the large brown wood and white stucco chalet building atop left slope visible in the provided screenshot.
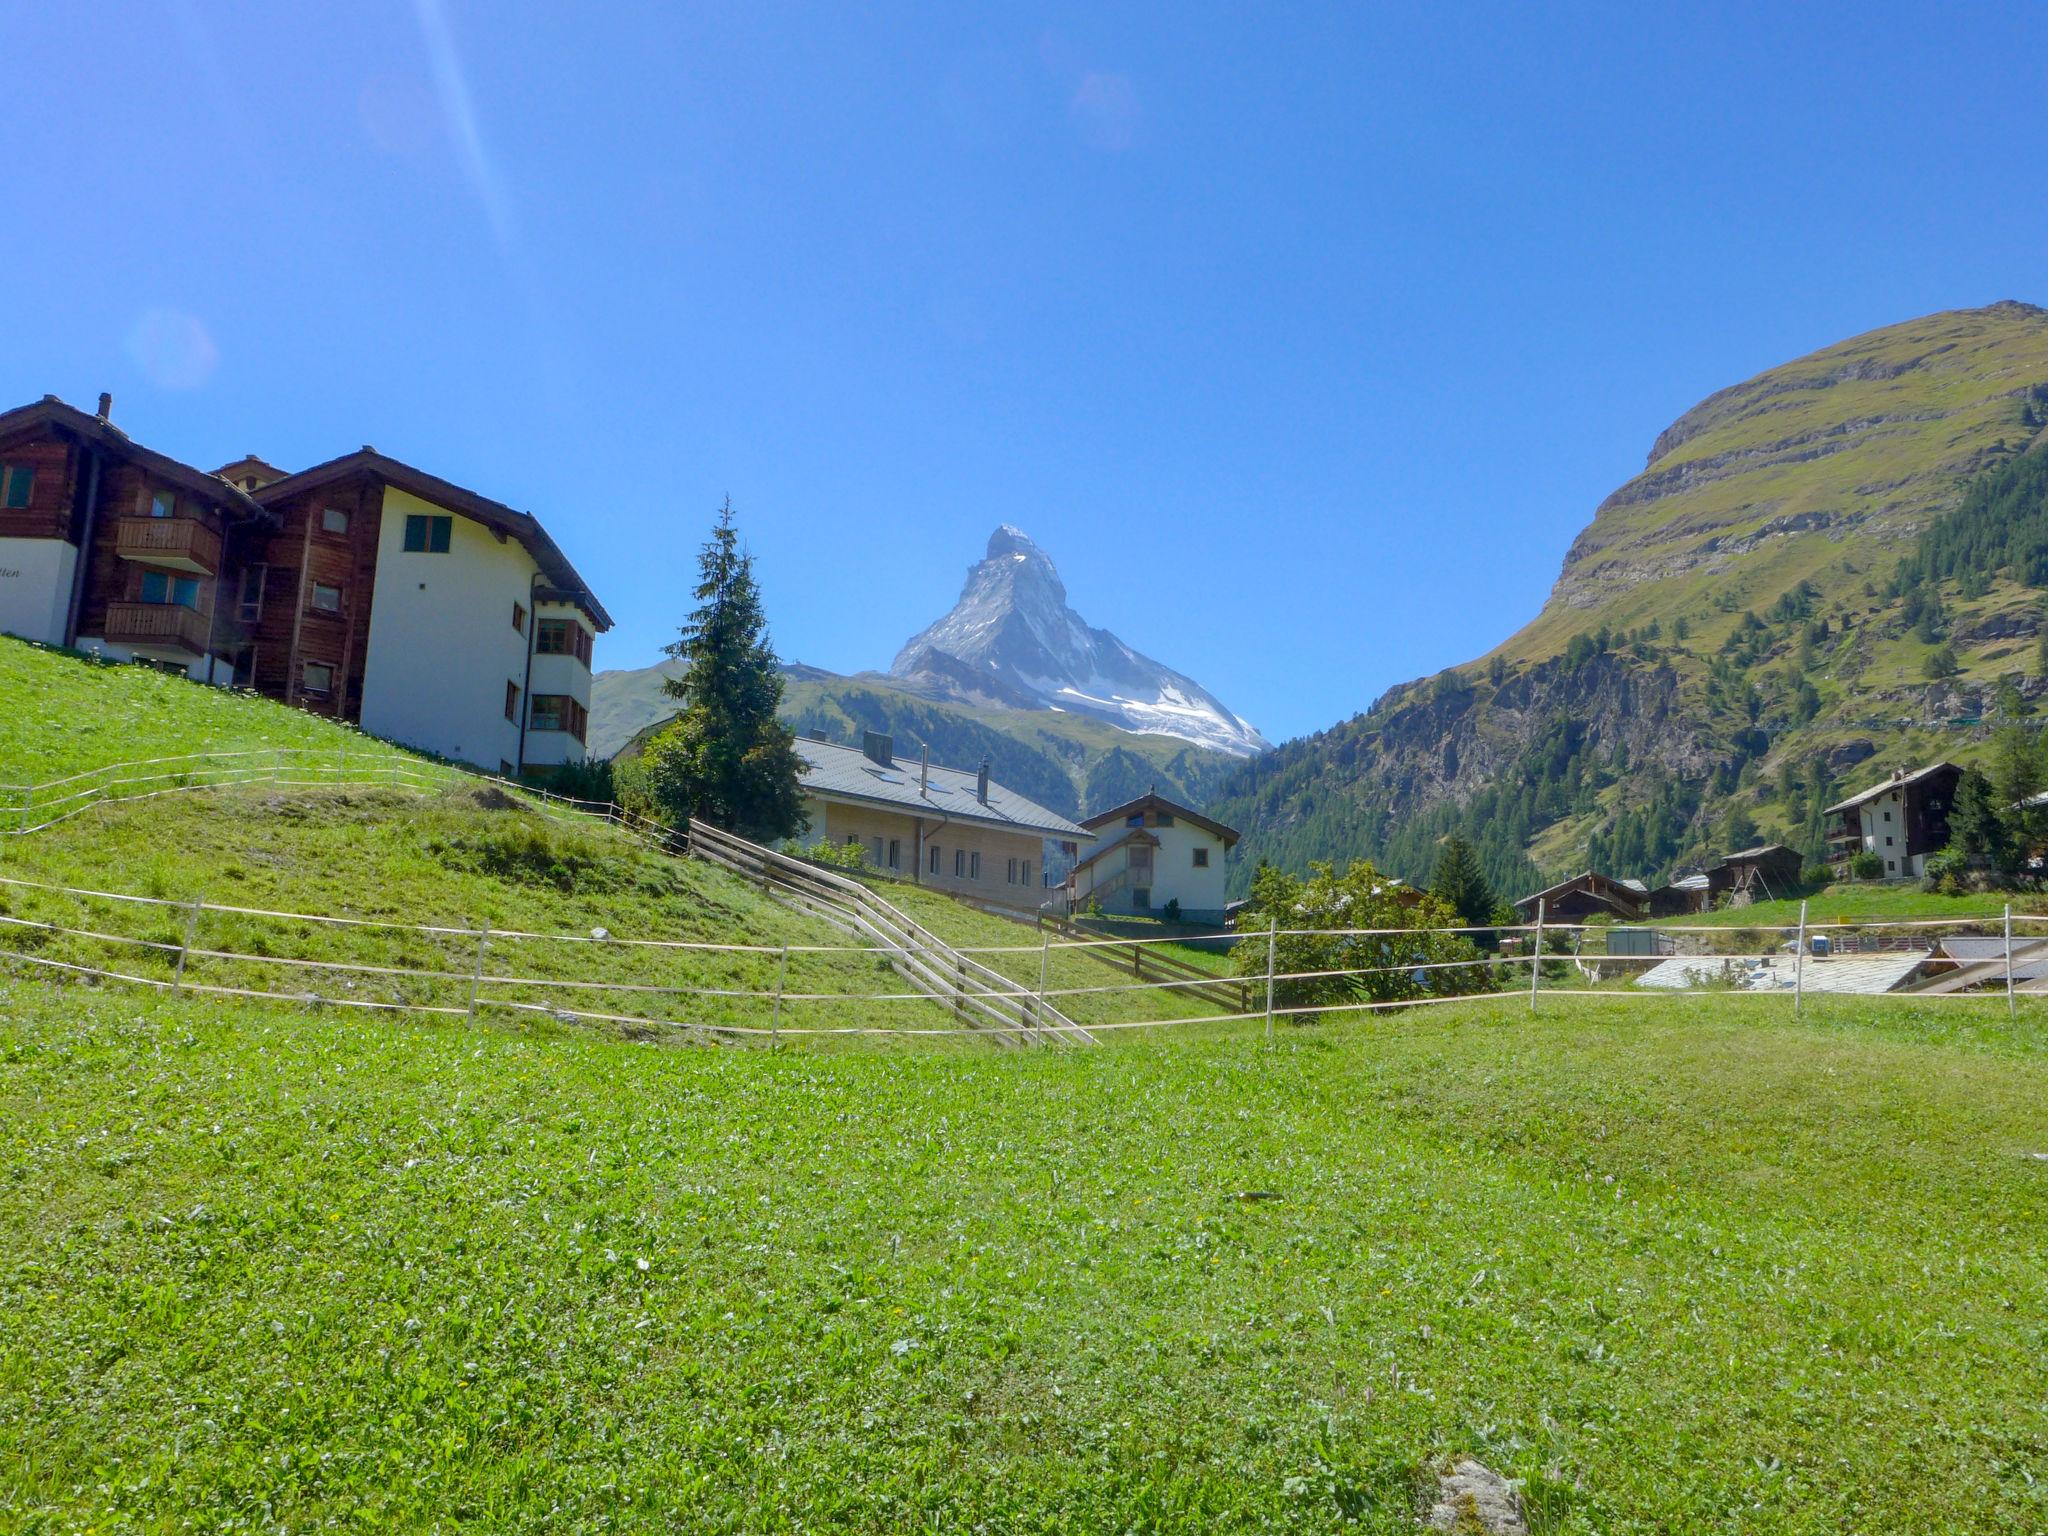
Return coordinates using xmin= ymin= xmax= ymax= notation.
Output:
xmin=0 ymin=395 xmax=612 ymax=772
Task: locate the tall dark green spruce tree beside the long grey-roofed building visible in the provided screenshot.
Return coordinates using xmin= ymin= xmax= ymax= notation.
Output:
xmin=647 ymin=498 xmax=803 ymax=840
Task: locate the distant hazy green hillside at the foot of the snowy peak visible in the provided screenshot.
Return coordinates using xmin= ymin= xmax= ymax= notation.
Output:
xmin=590 ymin=668 xmax=1241 ymax=817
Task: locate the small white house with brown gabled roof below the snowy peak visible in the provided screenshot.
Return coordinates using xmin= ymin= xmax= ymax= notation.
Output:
xmin=1067 ymin=791 xmax=1237 ymax=924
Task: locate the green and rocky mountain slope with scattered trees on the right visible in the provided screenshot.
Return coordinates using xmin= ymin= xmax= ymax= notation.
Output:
xmin=1208 ymin=303 xmax=2048 ymax=893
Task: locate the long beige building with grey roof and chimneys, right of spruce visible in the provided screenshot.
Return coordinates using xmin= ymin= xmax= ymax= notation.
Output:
xmin=797 ymin=731 xmax=1096 ymax=909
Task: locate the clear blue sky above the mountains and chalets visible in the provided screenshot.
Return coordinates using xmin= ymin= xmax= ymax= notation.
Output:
xmin=0 ymin=0 xmax=2048 ymax=739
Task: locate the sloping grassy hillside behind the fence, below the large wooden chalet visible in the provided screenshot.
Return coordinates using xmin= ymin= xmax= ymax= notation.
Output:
xmin=0 ymin=641 xmax=1212 ymax=1049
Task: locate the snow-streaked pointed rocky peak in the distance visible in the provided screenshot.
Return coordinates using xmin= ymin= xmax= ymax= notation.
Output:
xmin=889 ymin=524 xmax=1268 ymax=756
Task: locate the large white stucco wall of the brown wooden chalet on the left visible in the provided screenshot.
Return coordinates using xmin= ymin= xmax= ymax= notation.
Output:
xmin=362 ymin=487 xmax=536 ymax=770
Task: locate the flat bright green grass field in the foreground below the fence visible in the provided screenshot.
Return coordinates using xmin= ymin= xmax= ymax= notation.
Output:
xmin=0 ymin=981 xmax=2048 ymax=1536
